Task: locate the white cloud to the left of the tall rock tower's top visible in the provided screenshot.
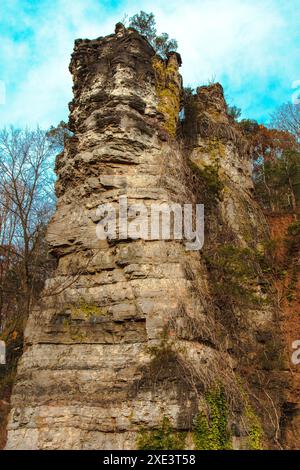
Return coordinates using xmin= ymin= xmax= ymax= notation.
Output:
xmin=0 ymin=0 xmax=119 ymax=127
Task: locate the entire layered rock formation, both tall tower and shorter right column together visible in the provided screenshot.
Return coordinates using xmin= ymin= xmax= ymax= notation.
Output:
xmin=6 ymin=25 xmax=296 ymax=449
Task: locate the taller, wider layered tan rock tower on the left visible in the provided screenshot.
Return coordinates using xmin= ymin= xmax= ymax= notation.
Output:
xmin=7 ymin=25 xmax=231 ymax=449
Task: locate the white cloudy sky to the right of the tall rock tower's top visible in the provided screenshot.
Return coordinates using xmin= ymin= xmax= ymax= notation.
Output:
xmin=129 ymin=0 xmax=300 ymax=118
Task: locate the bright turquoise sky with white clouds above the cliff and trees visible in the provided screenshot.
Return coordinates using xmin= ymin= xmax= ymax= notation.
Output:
xmin=0 ymin=0 xmax=300 ymax=128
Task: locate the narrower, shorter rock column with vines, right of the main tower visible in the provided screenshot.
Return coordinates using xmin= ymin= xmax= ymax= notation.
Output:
xmin=188 ymin=83 xmax=286 ymax=448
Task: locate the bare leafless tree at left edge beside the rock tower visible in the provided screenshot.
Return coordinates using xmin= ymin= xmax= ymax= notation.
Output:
xmin=0 ymin=128 xmax=54 ymax=332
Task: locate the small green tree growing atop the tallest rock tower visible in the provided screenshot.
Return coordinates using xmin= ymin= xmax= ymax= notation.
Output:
xmin=129 ymin=11 xmax=178 ymax=59
